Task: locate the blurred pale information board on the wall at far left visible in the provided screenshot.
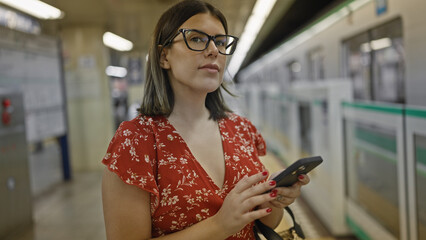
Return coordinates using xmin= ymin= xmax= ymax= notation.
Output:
xmin=0 ymin=27 xmax=66 ymax=142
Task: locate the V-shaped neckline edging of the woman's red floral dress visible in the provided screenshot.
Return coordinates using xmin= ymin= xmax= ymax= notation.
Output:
xmin=164 ymin=117 xmax=228 ymax=192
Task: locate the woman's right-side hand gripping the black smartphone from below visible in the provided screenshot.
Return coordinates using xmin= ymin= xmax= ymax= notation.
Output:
xmin=260 ymin=173 xmax=310 ymax=208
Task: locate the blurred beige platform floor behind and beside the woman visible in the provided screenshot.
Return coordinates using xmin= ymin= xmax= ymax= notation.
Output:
xmin=4 ymin=154 xmax=355 ymax=240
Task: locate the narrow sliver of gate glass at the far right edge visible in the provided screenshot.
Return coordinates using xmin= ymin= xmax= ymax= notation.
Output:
xmin=414 ymin=135 xmax=426 ymax=239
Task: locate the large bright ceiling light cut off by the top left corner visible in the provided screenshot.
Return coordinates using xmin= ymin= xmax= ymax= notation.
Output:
xmin=0 ymin=0 xmax=65 ymax=19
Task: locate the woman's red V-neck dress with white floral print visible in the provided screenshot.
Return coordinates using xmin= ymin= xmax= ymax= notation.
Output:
xmin=102 ymin=114 xmax=266 ymax=240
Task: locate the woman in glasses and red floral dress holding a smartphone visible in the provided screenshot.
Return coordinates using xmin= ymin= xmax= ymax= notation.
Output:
xmin=102 ymin=1 xmax=309 ymax=240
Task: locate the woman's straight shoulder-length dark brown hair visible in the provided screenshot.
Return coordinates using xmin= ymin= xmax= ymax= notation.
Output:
xmin=138 ymin=0 xmax=234 ymax=120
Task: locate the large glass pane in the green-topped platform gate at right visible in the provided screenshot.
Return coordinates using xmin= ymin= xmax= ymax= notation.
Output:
xmin=345 ymin=120 xmax=400 ymax=239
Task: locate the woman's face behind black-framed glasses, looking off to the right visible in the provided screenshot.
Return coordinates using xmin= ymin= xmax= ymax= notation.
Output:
xmin=161 ymin=13 xmax=226 ymax=96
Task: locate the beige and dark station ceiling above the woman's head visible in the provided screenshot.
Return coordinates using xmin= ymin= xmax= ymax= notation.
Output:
xmin=37 ymin=0 xmax=346 ymax=71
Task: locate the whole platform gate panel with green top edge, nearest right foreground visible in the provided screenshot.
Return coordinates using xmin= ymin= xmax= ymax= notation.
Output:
xmin=343 ymin=103 xmax=408 ymax=240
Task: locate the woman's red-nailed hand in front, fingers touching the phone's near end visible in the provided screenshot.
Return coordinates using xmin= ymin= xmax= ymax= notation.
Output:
xmin=212 ymin=172 xmax=276 ymax=236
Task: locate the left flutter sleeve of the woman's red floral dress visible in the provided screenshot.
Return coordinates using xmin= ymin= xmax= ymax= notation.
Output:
xmin=102 ymin=118 xmax=159 ymax=200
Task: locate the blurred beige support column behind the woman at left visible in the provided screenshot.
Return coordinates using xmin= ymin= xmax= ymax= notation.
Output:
xmin=61 ymin=26 xmax=114 ymax=171
